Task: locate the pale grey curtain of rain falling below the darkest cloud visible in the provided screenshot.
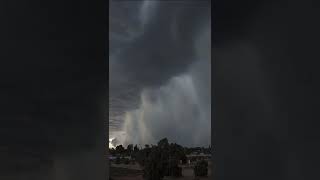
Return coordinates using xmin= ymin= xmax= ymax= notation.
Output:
xmin=121 ymin=25 xmax=211 ymax=146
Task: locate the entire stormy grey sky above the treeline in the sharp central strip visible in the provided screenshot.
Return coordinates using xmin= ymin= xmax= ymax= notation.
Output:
xmin=109 ymin=0 xmax=211 ymax=146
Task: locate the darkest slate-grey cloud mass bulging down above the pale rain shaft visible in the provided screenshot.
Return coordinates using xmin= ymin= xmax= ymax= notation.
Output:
xmin=117 ymin=1 xmax=210 ymax=87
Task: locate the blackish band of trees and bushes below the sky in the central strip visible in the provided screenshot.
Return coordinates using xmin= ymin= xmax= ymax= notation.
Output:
xmin=110 ymin=138 xmax=211 ymax=180
